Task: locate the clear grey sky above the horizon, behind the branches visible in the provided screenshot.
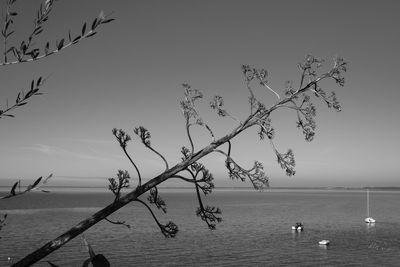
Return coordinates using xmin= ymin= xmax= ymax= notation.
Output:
xmin=0 ymin=0 xmax=400 ymax=187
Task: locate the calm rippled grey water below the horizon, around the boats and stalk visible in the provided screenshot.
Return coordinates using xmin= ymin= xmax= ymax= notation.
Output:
xmin=0 ymin=190 xmax=400 ymax=266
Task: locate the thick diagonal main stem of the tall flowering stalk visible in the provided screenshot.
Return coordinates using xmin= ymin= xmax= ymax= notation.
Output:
xmin=13 ymin=55 xmax=346 ymax=266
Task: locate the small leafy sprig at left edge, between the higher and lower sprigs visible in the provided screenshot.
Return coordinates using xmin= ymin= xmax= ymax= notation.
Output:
xmin=0 ymin=77 xmax=46 ymax=119
